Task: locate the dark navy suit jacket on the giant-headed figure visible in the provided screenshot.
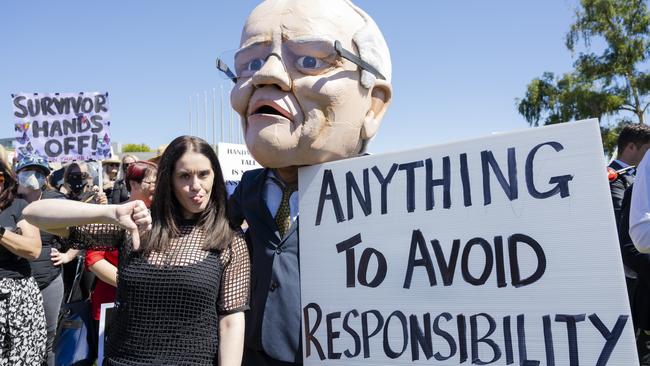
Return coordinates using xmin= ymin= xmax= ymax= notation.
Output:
xmin=228 ymin=169 xmax=302 ymax=363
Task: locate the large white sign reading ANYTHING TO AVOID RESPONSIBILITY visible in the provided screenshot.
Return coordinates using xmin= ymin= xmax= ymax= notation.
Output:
xmin=299 ymin=120 xmax=638 ymax=366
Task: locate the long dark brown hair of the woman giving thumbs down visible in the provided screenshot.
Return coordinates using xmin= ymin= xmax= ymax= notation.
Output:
xmin=143 ymin=136 xmax=233 ymax=253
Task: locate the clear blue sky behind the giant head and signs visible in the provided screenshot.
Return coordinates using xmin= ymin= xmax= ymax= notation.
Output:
xmin=0 ymin=0 xmax=577 ymax=153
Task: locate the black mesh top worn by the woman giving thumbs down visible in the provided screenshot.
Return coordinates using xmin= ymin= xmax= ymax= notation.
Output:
xmin=69 ymin=222 xmax=250 ymax=365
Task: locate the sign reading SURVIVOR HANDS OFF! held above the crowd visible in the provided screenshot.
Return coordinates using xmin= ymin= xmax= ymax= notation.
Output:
xmin=12 ymin=93 xmax=111 ymax=162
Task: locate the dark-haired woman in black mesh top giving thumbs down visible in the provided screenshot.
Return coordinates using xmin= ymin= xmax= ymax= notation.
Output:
xmin=25 ymin=136 xmax=250 ymax=366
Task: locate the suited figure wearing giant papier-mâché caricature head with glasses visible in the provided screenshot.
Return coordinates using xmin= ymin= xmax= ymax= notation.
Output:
xmin=224 ymin=0 xmax=391 ymax=366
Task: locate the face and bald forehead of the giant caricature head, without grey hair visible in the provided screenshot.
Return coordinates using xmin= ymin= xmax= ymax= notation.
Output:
xmin=231 ymin=0 xmax=390 ymax=168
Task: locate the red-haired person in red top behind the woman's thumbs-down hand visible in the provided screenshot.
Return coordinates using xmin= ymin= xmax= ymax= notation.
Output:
xmin=86 ymin=161 xmax=158 ymax=354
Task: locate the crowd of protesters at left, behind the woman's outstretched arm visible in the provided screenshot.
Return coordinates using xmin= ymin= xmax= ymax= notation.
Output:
xmin=0 ymin=142 xmax=170 ymax=365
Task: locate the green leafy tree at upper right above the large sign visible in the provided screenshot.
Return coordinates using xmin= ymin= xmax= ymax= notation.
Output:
xmin=517 ymin=0 xmax=650 ymax=153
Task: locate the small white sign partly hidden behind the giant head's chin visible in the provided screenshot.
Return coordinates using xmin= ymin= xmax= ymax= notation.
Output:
xmin=217 ymin=142 xmax=262 ymax=194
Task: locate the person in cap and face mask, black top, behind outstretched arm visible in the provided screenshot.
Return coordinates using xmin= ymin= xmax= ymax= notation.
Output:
xmin=16 ymin=155 xmax=73 ymax=366
